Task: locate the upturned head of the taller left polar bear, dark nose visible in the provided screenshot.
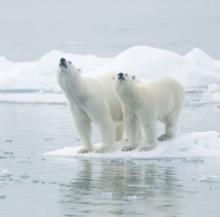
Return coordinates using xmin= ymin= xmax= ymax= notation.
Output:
xmin=58 ymin=58 xmax=81 ymax=75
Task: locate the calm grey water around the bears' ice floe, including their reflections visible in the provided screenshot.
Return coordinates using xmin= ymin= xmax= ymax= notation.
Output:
xmin=0 ymin=99 xmax=220 ymax=217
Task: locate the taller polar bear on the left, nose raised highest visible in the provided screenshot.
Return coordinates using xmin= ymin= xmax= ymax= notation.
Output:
xmin=58 ymin=58 xmax=123 ymax=153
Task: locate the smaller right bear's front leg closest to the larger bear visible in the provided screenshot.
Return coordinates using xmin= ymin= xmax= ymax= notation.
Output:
xmin=122 ymin=112 xmax=139 ymax=151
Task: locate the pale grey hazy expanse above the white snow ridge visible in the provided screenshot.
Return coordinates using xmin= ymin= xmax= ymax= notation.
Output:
xmin=0 ymin=0 xmax=220 ymax=60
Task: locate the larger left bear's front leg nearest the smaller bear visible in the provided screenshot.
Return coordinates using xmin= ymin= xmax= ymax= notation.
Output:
xmin=96 ymin=115 xmax=115 ymax=153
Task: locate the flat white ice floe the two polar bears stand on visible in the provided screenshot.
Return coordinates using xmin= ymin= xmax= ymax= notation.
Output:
xmin=44 ymin=131 xmax=220 ymax=159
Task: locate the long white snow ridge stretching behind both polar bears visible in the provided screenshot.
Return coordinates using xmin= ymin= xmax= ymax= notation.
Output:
xmin=0 ymin=46 xmax=220 ymax=103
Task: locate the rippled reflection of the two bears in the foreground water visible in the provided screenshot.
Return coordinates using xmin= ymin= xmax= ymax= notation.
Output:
xmin=60 ymin=160 xmax=182 ymax=217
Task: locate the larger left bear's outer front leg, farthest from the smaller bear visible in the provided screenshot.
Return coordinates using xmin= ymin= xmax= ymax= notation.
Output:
xmin=70 ymin=105 xmax=93 ymax=153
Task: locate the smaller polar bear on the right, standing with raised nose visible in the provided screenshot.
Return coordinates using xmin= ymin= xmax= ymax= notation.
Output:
xmin=113 ymin=72 xmax=185 ymax=151
